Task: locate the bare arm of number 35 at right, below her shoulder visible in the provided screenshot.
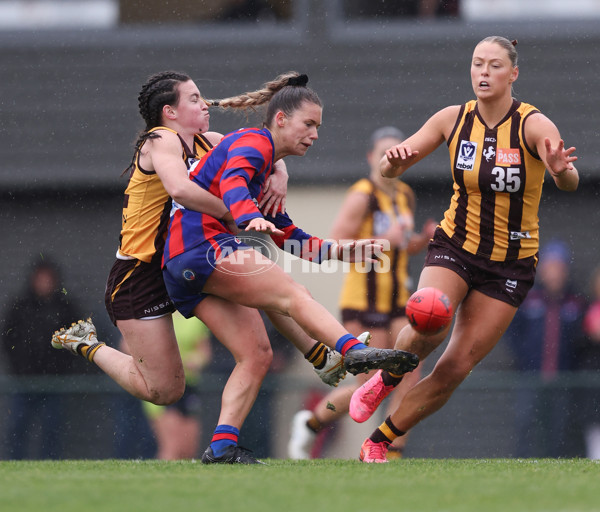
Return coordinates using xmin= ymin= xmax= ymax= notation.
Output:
xmin=525 ymin=114 xmax=579 ymax=192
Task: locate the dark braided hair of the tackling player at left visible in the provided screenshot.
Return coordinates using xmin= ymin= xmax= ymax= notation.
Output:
xmin=123 ymin=71 xmax=191 ymax=174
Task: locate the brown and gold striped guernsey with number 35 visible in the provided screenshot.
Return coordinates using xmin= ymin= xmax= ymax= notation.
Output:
xmin=441 ymin=100 xmax=545 ymax=261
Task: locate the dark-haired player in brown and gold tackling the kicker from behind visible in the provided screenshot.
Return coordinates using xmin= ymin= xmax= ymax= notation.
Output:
xmin=52 ymin=71 xmax=345 ymax=405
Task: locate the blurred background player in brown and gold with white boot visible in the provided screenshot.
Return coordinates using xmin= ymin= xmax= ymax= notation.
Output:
xmin=288 ymin=126 xmax=436 ymax=459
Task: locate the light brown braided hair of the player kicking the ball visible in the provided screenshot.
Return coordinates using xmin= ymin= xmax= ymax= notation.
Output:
xmin=208 ymin=71 xmax=322 ymax=126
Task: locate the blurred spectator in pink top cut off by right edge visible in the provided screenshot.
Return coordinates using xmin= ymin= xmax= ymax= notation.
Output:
xmin=577 ymin=267 xmax=600 ymax=459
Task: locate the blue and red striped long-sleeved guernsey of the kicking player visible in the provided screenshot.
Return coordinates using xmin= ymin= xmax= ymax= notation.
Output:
xmin=163 ymin=128 xmax=331 ymax=264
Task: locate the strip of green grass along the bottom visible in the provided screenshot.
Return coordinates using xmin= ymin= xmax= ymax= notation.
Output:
xmin=0 ymin=459 xmax=600 ymax=512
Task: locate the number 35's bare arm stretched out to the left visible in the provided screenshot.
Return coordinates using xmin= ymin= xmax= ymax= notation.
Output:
xmin=380 ymin=105 xmax=460 ymax=178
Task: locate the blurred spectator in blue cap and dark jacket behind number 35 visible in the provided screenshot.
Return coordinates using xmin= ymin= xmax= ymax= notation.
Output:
xmin=506 ymin=240 xmax=585 ymax=457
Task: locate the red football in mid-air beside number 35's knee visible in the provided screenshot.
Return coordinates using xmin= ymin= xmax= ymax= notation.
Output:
xmin=406 ymin=287 xmax=452 ymax=334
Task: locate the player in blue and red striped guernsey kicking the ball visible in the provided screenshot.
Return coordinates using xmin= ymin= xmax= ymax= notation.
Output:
xmin=163 ymin=72 xmax=418 ymax=464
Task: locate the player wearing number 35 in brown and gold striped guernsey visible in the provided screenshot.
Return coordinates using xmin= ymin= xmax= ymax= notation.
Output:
xmin=350 ymin=36 xmax=579 ymax=462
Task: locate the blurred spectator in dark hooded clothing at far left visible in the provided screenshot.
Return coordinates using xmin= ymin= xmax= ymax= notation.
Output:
xmin=2 ymin=257 xmax=81 ymax=459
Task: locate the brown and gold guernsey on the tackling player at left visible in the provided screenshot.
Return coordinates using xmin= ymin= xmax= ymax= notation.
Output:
xmin=117 ymin=126 xmax=212 ymax=263
